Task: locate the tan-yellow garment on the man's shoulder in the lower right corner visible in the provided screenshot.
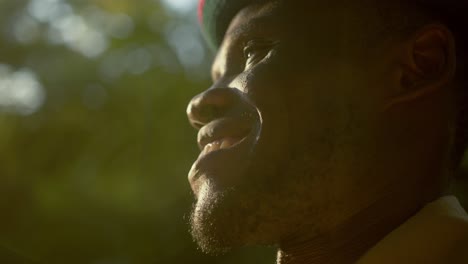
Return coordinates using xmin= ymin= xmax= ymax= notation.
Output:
xmin=357 ymin=196 xmax=468 ymax=264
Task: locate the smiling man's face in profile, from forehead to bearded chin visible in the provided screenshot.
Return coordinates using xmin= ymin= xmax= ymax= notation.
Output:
xmin=187 ymin=1 xmax=454 ymax=255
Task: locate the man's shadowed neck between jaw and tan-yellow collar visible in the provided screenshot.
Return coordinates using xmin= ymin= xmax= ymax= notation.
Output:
xmin=277 ymin=186 xmax=438 ymax=264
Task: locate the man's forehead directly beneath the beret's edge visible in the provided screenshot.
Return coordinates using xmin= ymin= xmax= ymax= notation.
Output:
xmin=219 ymin=0 xmax=377 ymax=50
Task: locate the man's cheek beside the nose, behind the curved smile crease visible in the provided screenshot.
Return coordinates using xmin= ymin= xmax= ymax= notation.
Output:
xmin=231 ymin=54 xmax=347 ymax=167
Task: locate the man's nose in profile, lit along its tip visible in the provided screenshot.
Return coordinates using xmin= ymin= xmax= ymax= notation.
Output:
xmin=187 ymin=88 xmax=238 ymax=129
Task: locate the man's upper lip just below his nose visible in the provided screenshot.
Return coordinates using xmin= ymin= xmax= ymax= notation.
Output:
xmin=197 ymin=117 xmax=252 ymax=150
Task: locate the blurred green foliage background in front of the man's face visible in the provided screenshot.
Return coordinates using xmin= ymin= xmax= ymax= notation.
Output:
xmin=0 ymin=0 xmax=464 ymax=264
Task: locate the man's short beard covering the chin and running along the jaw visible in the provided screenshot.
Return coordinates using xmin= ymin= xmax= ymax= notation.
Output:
xmin=190 ymin=96 xmax=353 ymax=254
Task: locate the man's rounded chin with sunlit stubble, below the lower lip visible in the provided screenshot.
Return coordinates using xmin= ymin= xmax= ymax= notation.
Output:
xmin=190 ymin=171 xmax=286 ymax=255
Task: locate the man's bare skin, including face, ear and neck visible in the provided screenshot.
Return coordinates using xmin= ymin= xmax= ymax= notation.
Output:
xmin=187 ymin=1 xmax=455 ymax=264
